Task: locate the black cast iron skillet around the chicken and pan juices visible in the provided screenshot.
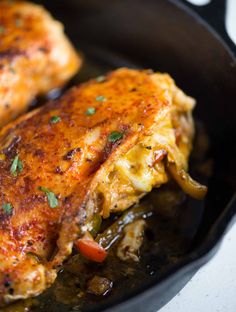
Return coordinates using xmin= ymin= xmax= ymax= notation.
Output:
xmin=30 ymin=0 xmax=236 ymax=312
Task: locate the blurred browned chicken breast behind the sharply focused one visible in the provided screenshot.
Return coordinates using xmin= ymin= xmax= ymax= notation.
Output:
xmin=0 ymin=1 xmax=81 ymax=126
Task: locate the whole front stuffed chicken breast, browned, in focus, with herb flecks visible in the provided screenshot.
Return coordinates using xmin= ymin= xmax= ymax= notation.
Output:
xmin=0 ymin=69 xmax=206 ymax=303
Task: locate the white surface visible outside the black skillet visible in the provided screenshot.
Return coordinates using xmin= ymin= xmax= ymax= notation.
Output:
xmin=159 ymin=0 xmax=236 ymax=312
